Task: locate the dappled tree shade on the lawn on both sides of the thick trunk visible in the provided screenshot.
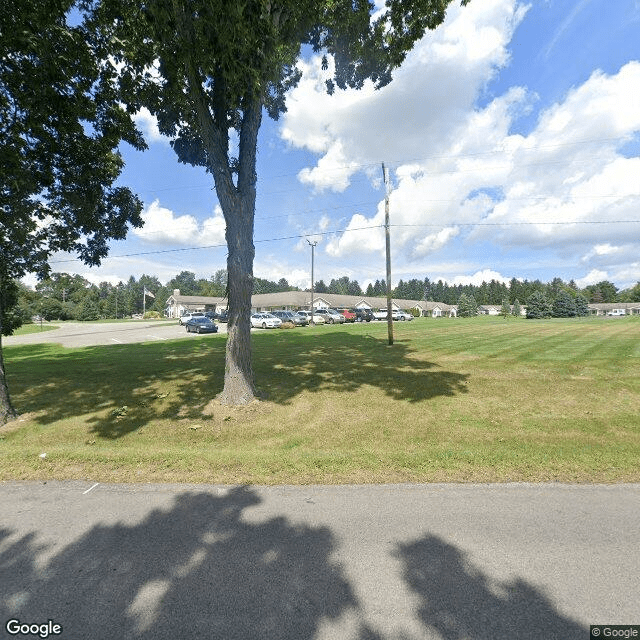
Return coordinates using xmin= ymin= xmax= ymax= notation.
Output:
xmin=5 ymin=331 xmax=468 ymax=439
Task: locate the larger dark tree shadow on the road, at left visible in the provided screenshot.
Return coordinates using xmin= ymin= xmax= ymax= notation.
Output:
xmin=0 ymin=488 xmax=356 ymax=640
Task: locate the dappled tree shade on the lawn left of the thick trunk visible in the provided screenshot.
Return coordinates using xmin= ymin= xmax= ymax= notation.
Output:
xmin=5 ymin=336 xmax=225 ymax=439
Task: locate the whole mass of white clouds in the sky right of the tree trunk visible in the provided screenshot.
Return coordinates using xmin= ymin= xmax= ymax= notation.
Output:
xmin=281 ymin=0 xmax=640 ymax=288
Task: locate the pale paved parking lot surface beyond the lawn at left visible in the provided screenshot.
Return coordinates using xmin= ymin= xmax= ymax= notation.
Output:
xmin=2 ymin=320 xmax=227 ymax=347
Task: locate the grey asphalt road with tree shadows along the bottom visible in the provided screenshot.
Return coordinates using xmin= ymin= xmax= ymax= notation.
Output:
xmin=0 ymin=481 xmax=640 ymax=640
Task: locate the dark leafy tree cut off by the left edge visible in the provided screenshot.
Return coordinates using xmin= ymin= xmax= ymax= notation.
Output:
xmin=0 ymin=0 xmax=144 ymax=424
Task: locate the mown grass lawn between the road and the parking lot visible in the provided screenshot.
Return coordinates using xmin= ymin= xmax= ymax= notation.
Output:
xmin=0 ymin=317 xmax=640 ymax=484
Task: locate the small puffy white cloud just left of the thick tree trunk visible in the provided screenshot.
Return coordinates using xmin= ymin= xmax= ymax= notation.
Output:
xmin=133 ymin=200 xmax=226 ymax=247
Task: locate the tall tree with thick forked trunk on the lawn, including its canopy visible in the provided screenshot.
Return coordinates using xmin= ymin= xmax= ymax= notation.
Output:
xmin=81 ymin=0 xmax=467 ymax=404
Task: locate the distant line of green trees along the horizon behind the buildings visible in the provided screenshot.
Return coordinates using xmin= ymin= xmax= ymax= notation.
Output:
xmin=14 ymin=269 xmax=640 ymax=322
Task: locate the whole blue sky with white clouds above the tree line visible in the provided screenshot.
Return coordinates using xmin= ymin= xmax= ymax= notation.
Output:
xmin=46 ymin=0 xmax=640 ymax=288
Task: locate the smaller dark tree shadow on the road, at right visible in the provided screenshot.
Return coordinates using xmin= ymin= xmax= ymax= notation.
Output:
xmin=397 ymin=535 xmax=589 ymax=640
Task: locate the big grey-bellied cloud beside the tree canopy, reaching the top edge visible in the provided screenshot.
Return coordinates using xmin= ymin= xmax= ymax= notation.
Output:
xmin=281 ymin=0 xmax=525 ymax=191
